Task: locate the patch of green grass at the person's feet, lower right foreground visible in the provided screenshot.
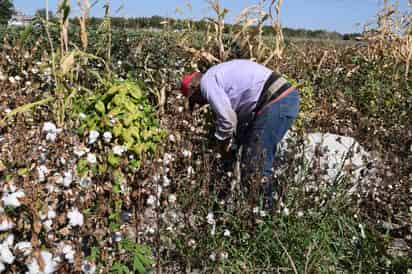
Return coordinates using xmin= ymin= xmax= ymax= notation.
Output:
xmin=162 ymin=168 xmax=412 ymax=273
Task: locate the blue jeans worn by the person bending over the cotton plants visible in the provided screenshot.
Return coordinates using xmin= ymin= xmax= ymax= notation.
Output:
xmin=239 ymin=90 xmax=300 ymax=206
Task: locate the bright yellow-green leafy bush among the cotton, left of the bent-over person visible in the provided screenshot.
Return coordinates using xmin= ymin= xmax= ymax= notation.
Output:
xmin=80 ymin=80 xmax=165 ymax=167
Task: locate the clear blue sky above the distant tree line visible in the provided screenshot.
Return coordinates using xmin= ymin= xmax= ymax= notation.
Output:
xmin=14 ymin=0 xmax=412 ymax=33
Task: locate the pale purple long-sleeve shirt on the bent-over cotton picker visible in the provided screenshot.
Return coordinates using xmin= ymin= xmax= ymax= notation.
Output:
xmin=200 ymin=60 xmax=272 ymax=140
